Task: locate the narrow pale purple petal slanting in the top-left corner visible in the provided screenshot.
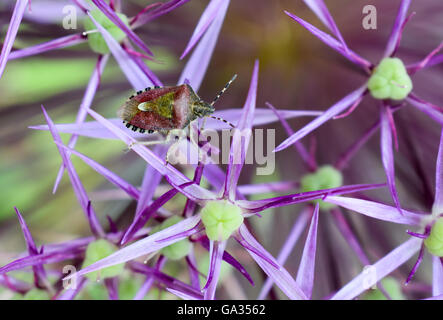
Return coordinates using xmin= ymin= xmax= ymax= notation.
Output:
xmin=0 ymin=0 xmax=29 ymax=79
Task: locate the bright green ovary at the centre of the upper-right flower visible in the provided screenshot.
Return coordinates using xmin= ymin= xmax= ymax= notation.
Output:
xmin=368 ymin=58 xmax=412 ymax=100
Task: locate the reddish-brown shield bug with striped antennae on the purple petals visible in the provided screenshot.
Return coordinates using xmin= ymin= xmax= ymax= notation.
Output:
xmin=117 ymin=75 xmax=237 ymax=163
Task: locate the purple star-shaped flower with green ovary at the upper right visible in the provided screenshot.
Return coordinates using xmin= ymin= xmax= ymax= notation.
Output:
xmin=275 ymin=0 xmax=443 ymax=212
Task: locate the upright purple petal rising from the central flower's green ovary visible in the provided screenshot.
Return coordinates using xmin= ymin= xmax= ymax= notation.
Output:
xmin=225 ymin=60 xmax=259 ymax=200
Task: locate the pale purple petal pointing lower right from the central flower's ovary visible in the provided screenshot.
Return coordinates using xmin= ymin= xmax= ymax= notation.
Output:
xmin=238 ymin=224 xmax=307 ymax=300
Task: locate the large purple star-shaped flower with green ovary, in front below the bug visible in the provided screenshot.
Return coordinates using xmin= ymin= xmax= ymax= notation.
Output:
xmin=57 ymin=62 xmax=386 ymax=299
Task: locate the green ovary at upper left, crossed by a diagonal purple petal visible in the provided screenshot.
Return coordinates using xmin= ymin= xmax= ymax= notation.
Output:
xmin=83 ymin=9 xmax=129 ymax=54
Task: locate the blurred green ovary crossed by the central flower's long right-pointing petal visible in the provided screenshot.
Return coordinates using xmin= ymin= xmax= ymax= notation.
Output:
xmin=300 ymin=165 xmax=343 ymax=210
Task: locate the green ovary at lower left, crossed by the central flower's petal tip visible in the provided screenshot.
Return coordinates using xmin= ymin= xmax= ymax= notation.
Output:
xmin=82 ymin=239 xmax=124 ymax=280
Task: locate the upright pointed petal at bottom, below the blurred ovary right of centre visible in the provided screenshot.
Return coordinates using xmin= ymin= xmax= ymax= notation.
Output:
xmin=296 ymin=203 xmax=319 ymax=299
